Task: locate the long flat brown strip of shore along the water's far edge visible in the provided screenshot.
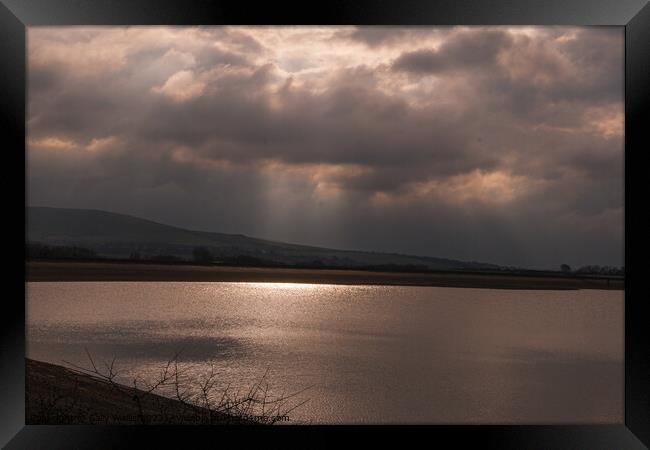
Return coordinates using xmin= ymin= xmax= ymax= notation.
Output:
xmin=26 ymin=261 xmax=625 ymax=290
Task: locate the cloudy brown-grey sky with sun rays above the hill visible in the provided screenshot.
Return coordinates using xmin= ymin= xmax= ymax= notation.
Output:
xmin=27 ymin=26 xmax=624 ymax=268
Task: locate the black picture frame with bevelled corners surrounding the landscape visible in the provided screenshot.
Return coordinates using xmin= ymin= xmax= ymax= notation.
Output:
xmin=0 ymin=0 xmax=650 ymax=449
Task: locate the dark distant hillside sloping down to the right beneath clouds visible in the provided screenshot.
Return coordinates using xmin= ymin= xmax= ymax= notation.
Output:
xmin=27 ymin=207 xmax=499 ymax=270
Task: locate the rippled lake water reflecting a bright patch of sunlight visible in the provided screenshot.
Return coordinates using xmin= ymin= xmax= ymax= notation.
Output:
xmin=26 ymin=282 xmax=624 ymax=424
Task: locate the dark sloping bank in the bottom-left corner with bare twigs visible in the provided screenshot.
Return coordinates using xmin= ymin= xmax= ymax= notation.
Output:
xmin=25 ymin=359 xmax=260 ymax=425
